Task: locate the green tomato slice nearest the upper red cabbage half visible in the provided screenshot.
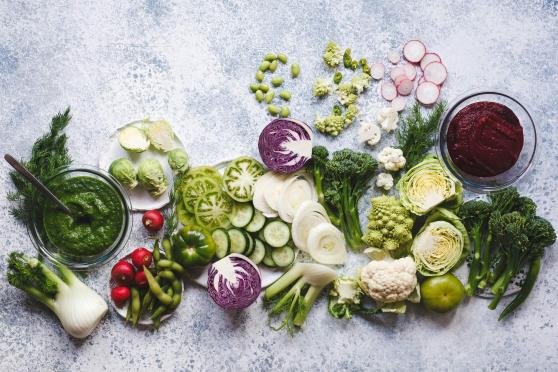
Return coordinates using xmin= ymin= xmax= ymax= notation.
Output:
xmin=223 ymin=156 xmax=264 ymax=202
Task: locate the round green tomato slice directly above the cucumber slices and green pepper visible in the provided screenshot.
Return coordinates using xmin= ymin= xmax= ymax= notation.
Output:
xmin=194 ymin=191 xmax=232 ymax=230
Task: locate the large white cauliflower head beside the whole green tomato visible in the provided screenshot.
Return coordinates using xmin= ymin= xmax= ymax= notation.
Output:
xmin=360 ymin=256 xmax=417 ymax=304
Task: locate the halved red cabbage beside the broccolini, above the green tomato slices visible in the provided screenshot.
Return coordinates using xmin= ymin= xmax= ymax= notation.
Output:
xmin=258 ymin=119 xmax=312 ymax=173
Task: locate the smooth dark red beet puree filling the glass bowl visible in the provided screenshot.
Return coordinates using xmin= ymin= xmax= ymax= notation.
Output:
xmin=447 ymin=102 xmax=523 ymax=177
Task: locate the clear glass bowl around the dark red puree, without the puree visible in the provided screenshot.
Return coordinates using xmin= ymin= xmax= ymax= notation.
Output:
xmin=436 ymin=90 xmax=538 ymax=193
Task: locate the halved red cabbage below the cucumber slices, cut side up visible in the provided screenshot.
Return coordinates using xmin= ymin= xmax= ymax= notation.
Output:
xmin=207 ymin=253 xmax=262 ymax=310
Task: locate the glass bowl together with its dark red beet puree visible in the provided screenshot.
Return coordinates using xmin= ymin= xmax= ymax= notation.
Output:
xmin=437 ymin=91 xmax=537 ymax=193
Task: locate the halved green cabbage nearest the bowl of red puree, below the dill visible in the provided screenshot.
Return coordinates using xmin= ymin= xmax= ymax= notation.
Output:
xmin=396 ymin=155 xmax=463 ymax=216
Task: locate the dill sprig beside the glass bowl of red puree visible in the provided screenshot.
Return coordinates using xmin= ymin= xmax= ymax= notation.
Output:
xmin=397 ymin=101 xmax=447 ymax=169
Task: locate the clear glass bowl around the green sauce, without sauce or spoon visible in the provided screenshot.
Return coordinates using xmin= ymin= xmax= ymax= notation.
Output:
xmin=28 ymin=166 xmax=132 ymax=270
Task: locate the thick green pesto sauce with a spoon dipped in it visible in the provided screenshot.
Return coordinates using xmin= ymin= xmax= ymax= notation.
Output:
xmin=43 ymin=176 xmax=124 ymax=256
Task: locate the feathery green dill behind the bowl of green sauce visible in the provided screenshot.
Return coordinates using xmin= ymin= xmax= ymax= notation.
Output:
xmin=7 ymin=107 xmax=72 ymax=223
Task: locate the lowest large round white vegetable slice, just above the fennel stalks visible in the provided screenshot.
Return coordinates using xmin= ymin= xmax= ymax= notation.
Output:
xmin=308 ymin=223 xmax=347 ymax=265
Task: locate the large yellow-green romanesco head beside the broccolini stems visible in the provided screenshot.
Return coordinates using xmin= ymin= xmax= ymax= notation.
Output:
xmin=363 ymin=195 xmax=413 ymax=251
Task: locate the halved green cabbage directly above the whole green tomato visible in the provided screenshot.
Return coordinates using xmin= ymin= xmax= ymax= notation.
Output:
xmin=411 ymin=208 xmax=469 ymax=276
